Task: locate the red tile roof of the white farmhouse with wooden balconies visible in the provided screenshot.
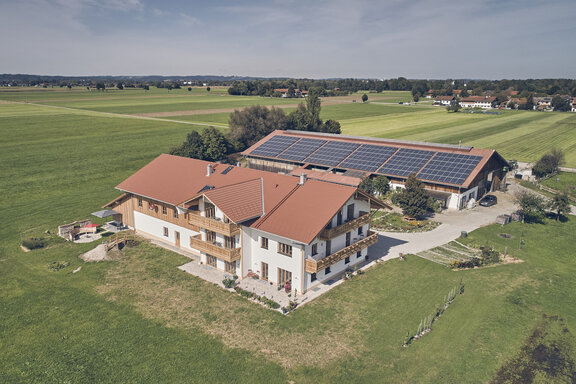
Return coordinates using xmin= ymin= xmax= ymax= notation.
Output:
xmin=117 ymin=154 xmax=372 ymax=244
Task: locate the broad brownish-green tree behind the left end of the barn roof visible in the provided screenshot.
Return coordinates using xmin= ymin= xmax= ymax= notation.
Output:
xmin=228 ymin=105 xmax=288 ymax=150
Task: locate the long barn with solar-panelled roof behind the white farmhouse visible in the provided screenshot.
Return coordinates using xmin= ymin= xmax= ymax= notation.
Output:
xmin=243 ymin=131 xmax=508 ymax=209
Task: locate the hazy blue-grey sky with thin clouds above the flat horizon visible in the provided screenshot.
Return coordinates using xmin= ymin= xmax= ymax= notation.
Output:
xmin=0 ymin=0 xmax=576 ymax=79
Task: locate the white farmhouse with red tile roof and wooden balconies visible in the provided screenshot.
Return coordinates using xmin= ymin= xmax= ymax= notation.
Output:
xmin=106 ymin=155 xmax=390 ymax=292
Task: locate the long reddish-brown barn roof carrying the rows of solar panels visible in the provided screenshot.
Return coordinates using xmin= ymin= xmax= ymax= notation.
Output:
xmin=243 ymin=130 xmax=507 ymax=188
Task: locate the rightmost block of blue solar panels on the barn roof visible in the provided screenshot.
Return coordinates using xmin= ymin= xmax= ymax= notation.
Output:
xmin=418 ymin=152 xmax=482 ymax=185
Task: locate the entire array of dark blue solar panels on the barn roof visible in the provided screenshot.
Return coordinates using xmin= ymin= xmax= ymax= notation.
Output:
xmin=251 ymin=135 xmax=482 ymax=185
